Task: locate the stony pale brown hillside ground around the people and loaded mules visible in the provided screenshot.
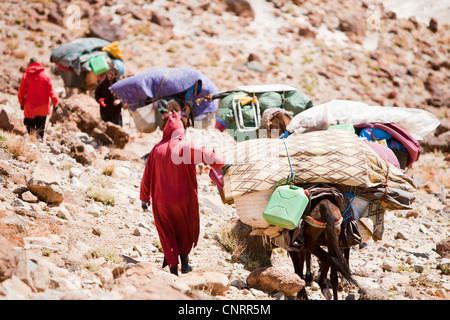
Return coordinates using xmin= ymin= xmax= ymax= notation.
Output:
xmin=0 ymin=0 xmax=450 ymax=300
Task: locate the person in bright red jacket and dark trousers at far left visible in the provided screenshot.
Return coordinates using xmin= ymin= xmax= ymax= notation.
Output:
xmin=17 ymin=57 xmax=59 ymax=141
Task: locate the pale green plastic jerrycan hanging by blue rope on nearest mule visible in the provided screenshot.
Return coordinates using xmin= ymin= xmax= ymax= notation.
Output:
xmin=263 ymin=185 xmax=309 ymax=229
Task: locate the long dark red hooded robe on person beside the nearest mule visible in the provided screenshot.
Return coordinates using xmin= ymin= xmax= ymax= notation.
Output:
xmin=140 ymin=112 xmax=225 ymax=267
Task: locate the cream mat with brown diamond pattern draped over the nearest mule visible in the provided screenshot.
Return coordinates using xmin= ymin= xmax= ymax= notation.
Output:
xmin=216 ymin=130 xmax=416 ymax=209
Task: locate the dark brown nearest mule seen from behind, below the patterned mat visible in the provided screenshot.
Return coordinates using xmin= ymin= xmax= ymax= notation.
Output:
xmin=289 ymin=198 xmax=359 ymax=300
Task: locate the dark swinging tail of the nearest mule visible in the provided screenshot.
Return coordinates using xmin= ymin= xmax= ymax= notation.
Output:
xmin=321 ymin=202 xmax=360 ymax=288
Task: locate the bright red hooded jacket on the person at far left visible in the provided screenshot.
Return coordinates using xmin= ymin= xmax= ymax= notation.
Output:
xmin=17 ymin=62 xmax=59 ymax=119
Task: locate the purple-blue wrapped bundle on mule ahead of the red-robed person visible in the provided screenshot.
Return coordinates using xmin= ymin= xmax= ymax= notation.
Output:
xmin=111 ymin=68 xmax=219 ymax=120
